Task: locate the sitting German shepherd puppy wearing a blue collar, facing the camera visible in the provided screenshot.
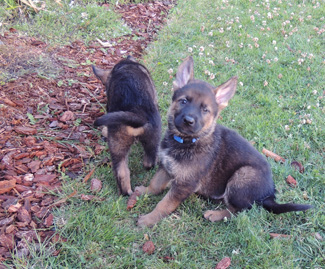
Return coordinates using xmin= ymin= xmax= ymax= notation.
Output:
xmin=136 ymin=57 xmax=311 ymax=226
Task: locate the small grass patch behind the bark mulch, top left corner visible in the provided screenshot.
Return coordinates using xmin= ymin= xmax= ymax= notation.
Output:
xmin=0 ymin=0 xmax=131 ymax=44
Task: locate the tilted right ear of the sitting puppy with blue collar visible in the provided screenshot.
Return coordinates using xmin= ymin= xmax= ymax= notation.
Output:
xmin=214 ymin=77 xmax=238 ymax=112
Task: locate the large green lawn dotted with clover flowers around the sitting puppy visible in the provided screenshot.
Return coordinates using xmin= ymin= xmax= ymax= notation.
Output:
xmin=3 ymin=0 xmax=325 ymax=268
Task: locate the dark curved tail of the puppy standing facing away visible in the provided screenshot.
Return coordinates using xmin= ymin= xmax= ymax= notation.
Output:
xmin=94 ymin=111 xmax=147 ymax=128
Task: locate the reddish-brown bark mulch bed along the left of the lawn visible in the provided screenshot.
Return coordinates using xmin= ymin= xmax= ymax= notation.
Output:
xmin=0 ymin=2 xmax=173 ymax=262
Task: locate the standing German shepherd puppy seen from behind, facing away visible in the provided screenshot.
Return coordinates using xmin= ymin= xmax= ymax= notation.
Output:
xmin=92 ymin=56 xmax=161 ymax=195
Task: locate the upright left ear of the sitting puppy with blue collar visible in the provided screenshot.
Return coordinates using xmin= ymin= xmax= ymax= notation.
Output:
xmin=173 ymin=56 xmax=194 ymax=91
